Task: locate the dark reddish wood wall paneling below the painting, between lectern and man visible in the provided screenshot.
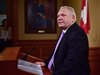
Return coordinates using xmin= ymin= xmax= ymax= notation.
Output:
xmin=18 ymin=40 xmax=56 ymax=60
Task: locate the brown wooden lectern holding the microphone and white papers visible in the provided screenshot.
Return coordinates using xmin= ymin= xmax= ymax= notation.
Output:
xmin=0 ymin=47 xmax=52 ymax=75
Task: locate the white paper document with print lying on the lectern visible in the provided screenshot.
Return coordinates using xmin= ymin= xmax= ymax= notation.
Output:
xmin=18 ymin=59 xmax=43 ymax=75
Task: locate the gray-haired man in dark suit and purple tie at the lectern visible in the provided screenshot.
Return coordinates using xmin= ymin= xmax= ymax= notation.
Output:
xmin=36 ymin=6 xmax=90 ymax=75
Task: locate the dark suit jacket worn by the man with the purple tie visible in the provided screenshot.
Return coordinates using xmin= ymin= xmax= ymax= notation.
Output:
xmin=44 ymin=22 xmax=90 ymax=75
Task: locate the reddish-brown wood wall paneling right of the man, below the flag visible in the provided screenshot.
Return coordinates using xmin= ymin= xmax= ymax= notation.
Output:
xmin=89 ymin=47 xmax=100 ymax=75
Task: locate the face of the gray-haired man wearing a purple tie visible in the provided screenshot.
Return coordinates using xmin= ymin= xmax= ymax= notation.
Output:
xmin=57 ymin=8 xmax=74 ymax=30
